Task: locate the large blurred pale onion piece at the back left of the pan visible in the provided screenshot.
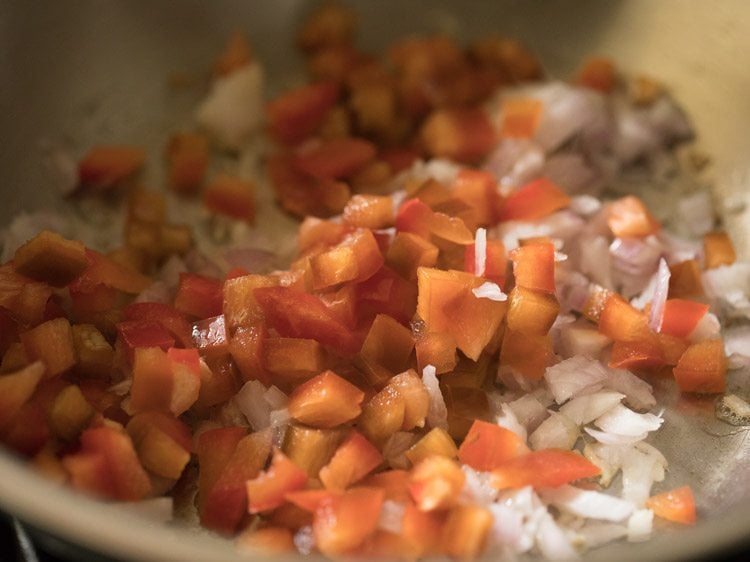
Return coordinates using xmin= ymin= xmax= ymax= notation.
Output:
xmin=195 ymin=62 xmax=263 ymax=149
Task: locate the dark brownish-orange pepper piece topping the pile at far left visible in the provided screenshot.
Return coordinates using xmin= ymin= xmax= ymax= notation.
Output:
xmin=13 ymin=230 xmax=88 ymax=287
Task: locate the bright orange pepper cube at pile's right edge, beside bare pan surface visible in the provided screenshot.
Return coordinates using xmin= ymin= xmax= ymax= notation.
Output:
xmin=673 ymin=340 xmax=727 ymax=394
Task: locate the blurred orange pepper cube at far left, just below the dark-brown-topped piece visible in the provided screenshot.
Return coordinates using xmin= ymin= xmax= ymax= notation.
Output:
xmin=21 ymin=318 xmax=77 ymax=377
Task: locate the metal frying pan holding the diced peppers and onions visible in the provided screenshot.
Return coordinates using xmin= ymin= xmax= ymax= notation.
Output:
xmin=0 ymin=0 xmax=750 ymax=561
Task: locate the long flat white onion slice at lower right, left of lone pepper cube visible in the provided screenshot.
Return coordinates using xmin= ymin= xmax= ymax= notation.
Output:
xmin=539 ymin=485 xmax=634 ymax=523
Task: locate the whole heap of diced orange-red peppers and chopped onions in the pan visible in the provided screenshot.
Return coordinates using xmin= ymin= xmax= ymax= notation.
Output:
xmin=0 ymin=4 xmax=750 ymax=560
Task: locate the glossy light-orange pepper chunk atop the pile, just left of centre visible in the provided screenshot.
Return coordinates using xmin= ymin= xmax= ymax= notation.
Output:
xmin=310 ymin=230 xmax=385 ymax=290
